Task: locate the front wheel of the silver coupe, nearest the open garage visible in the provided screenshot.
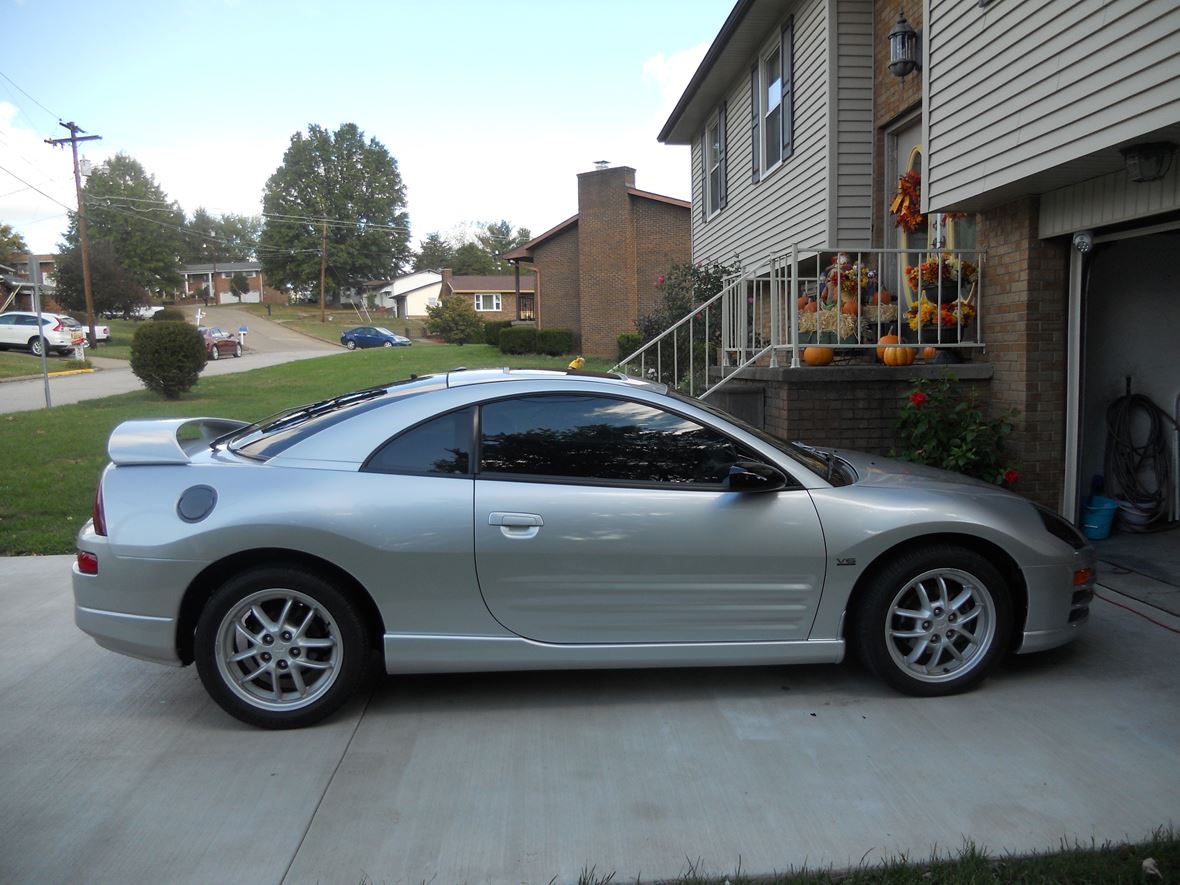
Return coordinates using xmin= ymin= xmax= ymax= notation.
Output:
xmin=853 ymin=544 xmax=1012 ymax=697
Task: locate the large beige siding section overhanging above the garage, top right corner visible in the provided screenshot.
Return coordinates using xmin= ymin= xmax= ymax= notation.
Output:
xmin=923 ymin=0 xmax=1180 ymax=210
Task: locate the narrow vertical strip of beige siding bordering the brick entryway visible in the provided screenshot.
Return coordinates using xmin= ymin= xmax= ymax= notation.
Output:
xmin=828 ymin=0 xmax=873 ymax=247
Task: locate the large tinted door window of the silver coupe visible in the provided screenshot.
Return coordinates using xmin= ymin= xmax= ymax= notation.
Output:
xmin=479 ymin=395 xmax=749 ymax=485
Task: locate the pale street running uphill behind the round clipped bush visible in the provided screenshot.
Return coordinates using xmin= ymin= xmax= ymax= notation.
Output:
xmin=0 ymin=307 xmax=347 ymax=413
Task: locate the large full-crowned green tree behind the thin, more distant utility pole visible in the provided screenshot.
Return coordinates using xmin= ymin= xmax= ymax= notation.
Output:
xmin=260 ymin=123 xmax=409 ymax=297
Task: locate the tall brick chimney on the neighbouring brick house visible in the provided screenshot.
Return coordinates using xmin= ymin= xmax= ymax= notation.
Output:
xmin=578 ymin=166 xmax=638 ymax=355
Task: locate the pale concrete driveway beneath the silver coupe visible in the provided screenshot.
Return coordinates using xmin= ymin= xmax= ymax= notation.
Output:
xmin=0 ymin=557 xmax=1180 ymax=885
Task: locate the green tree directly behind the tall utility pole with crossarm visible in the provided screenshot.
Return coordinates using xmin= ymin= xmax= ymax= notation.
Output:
xmin=61 ymin=153 xmax=184 ymax=290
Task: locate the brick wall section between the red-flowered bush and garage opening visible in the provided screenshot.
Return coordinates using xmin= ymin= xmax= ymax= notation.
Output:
xmin=979 ymin=196 xmax=1069 ymax=507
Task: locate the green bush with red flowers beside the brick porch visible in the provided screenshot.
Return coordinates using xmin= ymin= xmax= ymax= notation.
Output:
xmin=891 ymin=375 xmax=1020 ymax=486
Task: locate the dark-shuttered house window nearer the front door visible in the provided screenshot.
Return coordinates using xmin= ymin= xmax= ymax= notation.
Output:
xmin=750 ymin=19 xmax=794 ymax=182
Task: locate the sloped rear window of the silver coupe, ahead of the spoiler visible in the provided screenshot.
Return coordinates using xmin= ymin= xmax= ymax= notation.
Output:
xmin=224 ymin=375 xmax=446 ymax=460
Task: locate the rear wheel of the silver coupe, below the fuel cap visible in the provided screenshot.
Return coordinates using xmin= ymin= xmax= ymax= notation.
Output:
xmin=194 ymin=566 xmax=372 ymax=728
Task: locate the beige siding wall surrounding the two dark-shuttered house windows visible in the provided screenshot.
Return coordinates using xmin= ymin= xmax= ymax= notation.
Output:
xmin=693 ymin=0 xmax=835 ymax=267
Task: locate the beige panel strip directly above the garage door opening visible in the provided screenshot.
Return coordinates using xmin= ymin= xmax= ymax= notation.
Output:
xmin=1040 ymin=162 xmax=1180 ymax=237
